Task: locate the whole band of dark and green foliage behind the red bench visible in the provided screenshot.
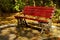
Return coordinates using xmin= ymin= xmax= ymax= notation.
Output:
xmin=0 ymin=0 xmax=59 ymax=12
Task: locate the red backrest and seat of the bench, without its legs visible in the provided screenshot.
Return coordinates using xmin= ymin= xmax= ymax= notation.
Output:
xmin=15 ymin=6 xmax=54 ymax=22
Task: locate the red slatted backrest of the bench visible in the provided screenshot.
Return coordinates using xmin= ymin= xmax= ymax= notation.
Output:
xmin=23 ymin=6 xmax=54 ymax=18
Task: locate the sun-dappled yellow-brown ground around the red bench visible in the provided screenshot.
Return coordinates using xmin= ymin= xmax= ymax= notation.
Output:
xmin=0 ymin=13 xmax=60 ymax=40
